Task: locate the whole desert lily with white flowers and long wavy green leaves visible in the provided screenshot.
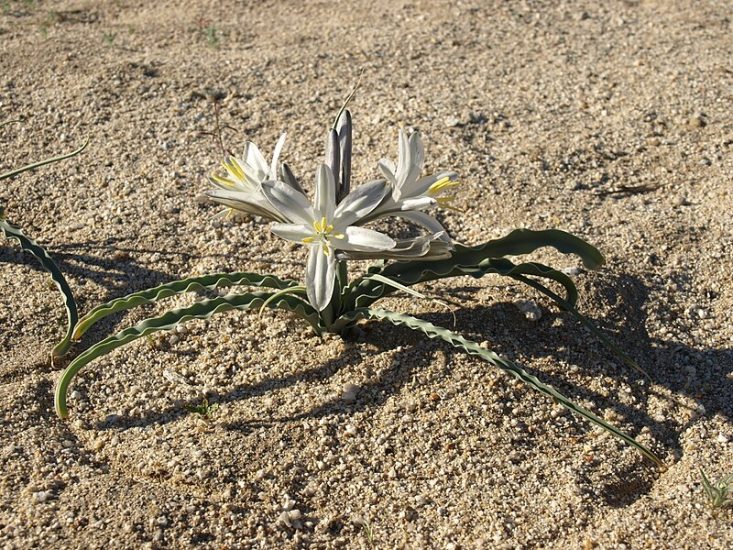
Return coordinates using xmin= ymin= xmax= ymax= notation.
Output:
xmin=55 ymin=109 xmax=661 ymax=465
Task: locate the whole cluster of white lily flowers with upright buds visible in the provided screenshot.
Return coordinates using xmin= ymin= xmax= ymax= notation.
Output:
xmin=208 ymin=110 xmax=458 ymax=311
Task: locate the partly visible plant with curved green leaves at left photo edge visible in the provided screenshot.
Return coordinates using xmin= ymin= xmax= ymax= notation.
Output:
xmin=0 ymin=122 xmax=88 ymax=362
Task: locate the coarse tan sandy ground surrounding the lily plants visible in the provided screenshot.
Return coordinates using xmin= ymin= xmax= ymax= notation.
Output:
xmin=0 ymin=0 xmax=733 ymax=549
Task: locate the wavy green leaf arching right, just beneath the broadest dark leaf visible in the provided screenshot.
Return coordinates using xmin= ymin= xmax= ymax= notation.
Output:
xmin=344 ymin=258 xmax=578 ymax=311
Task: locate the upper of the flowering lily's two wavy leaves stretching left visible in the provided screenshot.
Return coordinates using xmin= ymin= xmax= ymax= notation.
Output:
xmin=68 ymin=272 xmax=298 ymax=340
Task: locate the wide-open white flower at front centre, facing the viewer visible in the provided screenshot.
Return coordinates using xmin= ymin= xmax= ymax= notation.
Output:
xmin=262 ymin=164 xmax=396 ymax=311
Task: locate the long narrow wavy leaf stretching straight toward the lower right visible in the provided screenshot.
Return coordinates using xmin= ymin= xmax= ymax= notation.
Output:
xmin=351 ymin=308 xmax=663 ymax=467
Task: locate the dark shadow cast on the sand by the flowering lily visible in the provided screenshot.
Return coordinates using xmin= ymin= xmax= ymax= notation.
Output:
xmin=80 ymin=275 xmax=733 ymax=506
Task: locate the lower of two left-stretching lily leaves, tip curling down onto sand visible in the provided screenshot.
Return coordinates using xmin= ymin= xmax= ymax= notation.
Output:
xmin=54 ymin=292 xmax=318 ymax=418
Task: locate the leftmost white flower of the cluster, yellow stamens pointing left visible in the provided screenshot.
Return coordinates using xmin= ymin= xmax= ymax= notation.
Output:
xmin=206 ymin=134 xmax=293 ymax=222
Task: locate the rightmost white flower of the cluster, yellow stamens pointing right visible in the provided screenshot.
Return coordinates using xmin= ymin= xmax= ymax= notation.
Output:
xmin=369 ymin=130 xmax=459 ymax=242
